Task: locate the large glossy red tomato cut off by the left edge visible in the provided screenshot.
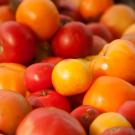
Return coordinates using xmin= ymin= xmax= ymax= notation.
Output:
xmin=0 ymin=21 xmax=36 ymax=64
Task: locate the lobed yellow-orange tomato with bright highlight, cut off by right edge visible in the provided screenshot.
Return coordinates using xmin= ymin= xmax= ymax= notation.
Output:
xmin=90 ymin=39 xmax=135 ymax=83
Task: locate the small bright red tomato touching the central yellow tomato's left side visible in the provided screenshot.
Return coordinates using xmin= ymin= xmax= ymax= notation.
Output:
xmin=24 ymin=63 xmax=54 ymax=92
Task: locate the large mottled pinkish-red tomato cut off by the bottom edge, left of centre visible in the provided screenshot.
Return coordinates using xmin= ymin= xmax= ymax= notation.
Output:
xmin=16 ymin=107 xmax=86 ymax=135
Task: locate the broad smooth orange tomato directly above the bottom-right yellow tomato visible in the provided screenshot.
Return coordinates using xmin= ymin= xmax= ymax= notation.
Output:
xmin=83 ymin=76 xmax=135 ymax=112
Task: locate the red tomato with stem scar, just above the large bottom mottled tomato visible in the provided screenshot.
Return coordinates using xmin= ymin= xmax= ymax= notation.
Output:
xmin=27 ymin=89 xmax=70 ymax=112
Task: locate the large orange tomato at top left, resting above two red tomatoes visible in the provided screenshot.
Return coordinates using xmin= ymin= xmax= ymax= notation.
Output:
xmin=16 ymin=0 xmax=60 ymax=39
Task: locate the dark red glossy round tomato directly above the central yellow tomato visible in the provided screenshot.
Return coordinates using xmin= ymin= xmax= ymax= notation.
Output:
xmin=52 ymin=21 xmax=92 ymax=58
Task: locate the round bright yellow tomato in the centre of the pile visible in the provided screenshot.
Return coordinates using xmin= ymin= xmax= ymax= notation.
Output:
xmin=52 ymin=59 xmax=91 ymax=96
